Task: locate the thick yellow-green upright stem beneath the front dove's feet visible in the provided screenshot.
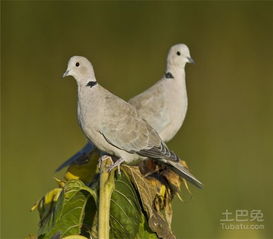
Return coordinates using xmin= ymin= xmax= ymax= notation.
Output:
xmin=98 ymin=157 xmax=115 ymax=239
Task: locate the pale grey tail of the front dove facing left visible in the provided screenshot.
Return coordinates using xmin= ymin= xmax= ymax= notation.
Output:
xmin=158 ymin=160 xmax=203 ymax=189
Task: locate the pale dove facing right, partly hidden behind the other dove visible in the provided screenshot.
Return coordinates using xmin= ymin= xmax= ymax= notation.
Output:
xmin=56 ymin=44 xmax=194 ymax=171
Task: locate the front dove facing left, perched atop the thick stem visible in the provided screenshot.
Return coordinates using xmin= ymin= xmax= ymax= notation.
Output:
xmin=63 ymin=56 xmax=202 ymax=187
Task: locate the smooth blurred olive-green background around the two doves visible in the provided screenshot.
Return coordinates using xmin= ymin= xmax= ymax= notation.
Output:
xmin=1 ymin=1 xmax=273 ymax=239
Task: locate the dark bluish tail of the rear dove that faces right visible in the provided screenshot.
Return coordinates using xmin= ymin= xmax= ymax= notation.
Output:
xmin=55 ymin=143 xmax=95 ymax=172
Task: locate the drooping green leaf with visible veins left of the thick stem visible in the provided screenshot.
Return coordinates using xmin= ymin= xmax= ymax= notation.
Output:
xmin=38 ymin=180 xmax=97 ymax=239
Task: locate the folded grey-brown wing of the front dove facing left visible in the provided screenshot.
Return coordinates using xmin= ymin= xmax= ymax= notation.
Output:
xmin=100 ymin=92 xmax=179 ymax=161
